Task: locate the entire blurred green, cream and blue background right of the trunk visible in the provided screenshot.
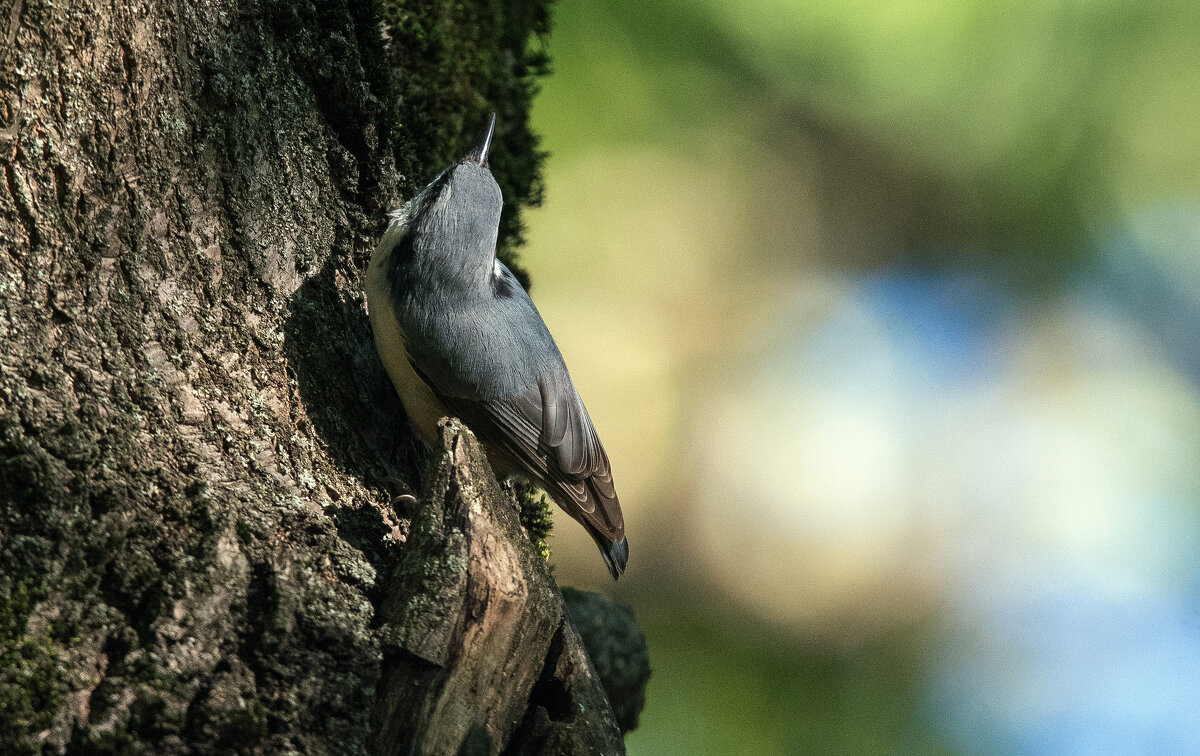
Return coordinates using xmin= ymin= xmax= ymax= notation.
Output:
xmin=522 ymin=0 xmax=1200 ymax=755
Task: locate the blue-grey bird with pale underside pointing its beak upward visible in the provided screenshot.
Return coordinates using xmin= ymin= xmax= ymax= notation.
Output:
xmin=366 ymin=113 xmax=629 ymax=580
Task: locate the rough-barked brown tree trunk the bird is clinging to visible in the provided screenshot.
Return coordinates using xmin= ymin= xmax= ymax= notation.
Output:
xmin=0 ymin=0 xmax=619 ymax=754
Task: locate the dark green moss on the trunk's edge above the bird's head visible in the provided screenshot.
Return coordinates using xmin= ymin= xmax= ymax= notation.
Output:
xmin=380 ymin=0 xmax=550 ymax=287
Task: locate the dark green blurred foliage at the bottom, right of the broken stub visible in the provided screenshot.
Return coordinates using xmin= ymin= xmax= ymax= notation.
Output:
xmin=626 ymin=592 xmax=947 ymax=756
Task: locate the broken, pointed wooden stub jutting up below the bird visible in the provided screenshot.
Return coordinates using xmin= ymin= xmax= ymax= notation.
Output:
xmin=372 ymin=420 xmax=624 ymax=755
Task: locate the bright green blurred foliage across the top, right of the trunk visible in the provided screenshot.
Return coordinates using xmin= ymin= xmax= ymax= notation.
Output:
xmin=535 ymin=0 xmax=1200 ymax=271
